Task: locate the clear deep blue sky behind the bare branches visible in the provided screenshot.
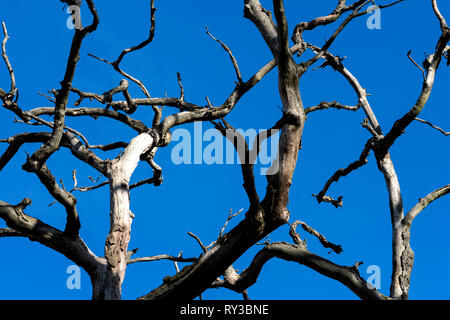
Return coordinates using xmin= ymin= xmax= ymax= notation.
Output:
xmin=0 ymin=0 xmax=450 ymax=299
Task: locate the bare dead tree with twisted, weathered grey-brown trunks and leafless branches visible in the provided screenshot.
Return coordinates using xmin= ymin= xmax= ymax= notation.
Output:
xmin=0 ymin=0 xmax=450 ymax=300
